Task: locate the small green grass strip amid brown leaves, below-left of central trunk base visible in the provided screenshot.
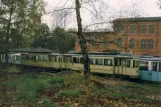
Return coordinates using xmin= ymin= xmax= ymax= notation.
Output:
xmin=57 ymin=89 xmax=82 ymax=97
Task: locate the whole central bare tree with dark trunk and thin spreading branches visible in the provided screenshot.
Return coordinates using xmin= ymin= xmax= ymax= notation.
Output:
xmin=49 ymin=0 xmax=144 ymax=77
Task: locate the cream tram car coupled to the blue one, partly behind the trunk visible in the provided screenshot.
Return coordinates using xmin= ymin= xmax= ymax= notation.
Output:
xmin=72 ymin=55 xmax=139 ymax=78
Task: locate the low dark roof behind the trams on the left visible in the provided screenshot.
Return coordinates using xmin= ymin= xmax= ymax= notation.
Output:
xmin=9 ymin=48 xmax=52 ymax=53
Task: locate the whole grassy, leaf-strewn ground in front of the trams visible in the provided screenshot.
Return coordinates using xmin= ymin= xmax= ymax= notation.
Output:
xmin=0 ymin=72 xmax=161 ymax=107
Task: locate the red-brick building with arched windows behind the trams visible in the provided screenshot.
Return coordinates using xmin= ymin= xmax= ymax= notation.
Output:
xmin=75 ymin=17 xmax=161 ymax=56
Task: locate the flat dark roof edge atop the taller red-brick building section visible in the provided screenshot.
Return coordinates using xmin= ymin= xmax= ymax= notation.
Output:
xmin=113 ymin=17 xmax=161 ymax=22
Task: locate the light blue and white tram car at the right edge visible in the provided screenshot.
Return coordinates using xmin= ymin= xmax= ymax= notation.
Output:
xmin=140 ymin=57 xmax=161 ymax=82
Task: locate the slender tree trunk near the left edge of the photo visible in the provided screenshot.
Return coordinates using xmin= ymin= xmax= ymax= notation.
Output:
xmin=5 ymin=1 xmax=14 ymax=65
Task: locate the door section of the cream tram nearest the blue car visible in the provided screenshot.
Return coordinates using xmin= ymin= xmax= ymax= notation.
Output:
xmin=115 ymin=58 xmax=127 ymax=74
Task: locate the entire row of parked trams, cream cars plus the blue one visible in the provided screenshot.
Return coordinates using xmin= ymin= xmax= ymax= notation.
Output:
xmin=1 ymin=52 xmax=161 ymax=82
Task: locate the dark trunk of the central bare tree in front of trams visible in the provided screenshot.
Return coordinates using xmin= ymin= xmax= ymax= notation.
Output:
xmin=75 ymin=0 xmax=90 ymax=79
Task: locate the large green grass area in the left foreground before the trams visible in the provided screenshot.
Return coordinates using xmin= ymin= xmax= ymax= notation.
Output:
xmin=2 ymin=73 xmax=64 ymax=106
